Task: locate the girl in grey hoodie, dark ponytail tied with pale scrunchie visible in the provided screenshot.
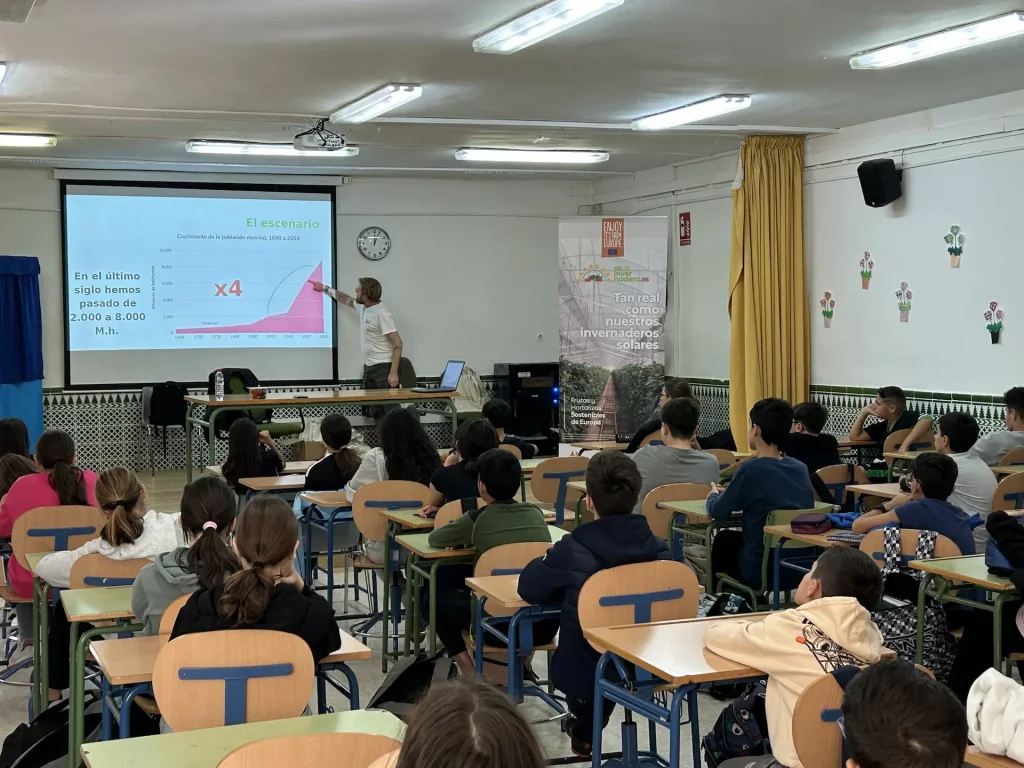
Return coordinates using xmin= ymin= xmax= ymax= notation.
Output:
xmin=131 ymin=477 xmax=240 ymax=635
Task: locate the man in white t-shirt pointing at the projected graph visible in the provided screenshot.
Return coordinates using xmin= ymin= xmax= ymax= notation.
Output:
xmin=309 ymin=278 xmax=401 ymax=411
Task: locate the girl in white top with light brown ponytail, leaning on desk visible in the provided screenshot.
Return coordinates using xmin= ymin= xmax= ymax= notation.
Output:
xmin=36 ymin=467 xmax=178 ymax=699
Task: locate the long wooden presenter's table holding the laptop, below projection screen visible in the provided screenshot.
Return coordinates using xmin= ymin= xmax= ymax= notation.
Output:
xmin=185 ymin=391 xmax=459 ymax=482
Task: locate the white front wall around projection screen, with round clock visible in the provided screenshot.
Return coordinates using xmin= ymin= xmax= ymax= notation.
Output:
xmin=0 ymin=175 xmax=583 ymax=387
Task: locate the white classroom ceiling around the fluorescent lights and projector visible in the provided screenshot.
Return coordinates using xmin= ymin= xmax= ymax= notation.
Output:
xmin=0 ymin=0 xmax=1024 ymax=177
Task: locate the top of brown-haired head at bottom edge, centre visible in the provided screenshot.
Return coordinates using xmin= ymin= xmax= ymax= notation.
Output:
xmin=395 ymin=680 xmax=546 ymax=768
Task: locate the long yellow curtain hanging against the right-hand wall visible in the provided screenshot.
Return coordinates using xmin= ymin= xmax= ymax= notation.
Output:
xmin=729 ymin=136 xmax=811 ymax=451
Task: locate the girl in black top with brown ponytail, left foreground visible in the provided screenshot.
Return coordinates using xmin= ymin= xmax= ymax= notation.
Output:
xmin=171 ymin=496 xmax=341 ymax=662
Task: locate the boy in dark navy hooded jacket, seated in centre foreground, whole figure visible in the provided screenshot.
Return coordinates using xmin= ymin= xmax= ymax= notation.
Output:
xmin=519 ymin=451 xmax=669 ymax=758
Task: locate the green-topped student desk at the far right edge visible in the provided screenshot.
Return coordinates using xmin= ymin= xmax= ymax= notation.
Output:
xmin=909 ymin=555 xmax=1020 ymax=671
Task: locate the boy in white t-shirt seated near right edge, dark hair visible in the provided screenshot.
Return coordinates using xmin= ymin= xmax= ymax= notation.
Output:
xmin=935 ymin=413 xmax=996 ymax=552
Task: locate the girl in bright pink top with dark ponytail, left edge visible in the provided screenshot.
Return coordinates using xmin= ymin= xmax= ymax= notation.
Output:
xmin=0 ymin=429 xmax=96 ymax=597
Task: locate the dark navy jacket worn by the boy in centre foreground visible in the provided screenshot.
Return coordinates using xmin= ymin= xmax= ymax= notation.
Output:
xmin=519 ymin=514 xmax=669 ymax=700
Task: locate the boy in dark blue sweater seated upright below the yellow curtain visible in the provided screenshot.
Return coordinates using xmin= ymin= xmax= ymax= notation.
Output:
xmin=707 ymin=397 xmax=814 ymax=587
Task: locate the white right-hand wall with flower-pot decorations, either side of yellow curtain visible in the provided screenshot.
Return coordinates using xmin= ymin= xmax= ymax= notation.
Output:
xmin=589 ymin=86 xmax=1024 ymax=394
